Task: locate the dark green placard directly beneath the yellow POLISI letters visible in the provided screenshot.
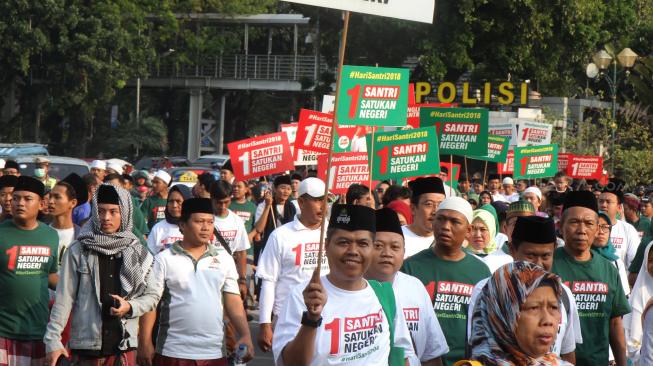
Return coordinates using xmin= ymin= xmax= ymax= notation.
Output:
xmin=419 ymin=108 xmax=489 ymax=156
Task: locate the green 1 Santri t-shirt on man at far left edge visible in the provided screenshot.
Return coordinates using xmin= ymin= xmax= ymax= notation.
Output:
xmin=0 ymin=220 xmax=59 ymax=340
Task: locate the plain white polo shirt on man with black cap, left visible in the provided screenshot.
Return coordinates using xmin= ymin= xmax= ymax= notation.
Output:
xmin=154 ymin=245 xmax=240 ymax=360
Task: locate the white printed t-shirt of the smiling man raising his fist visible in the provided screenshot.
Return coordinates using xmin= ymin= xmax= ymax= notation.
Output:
xmin=272 ymin=276 xmax=413 ymax=366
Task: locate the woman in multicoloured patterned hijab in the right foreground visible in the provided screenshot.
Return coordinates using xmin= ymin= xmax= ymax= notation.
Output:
xmin=470 ymin=262 xmax=571 ymax=366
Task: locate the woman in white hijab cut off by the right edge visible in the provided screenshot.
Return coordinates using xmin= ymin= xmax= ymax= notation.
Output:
xmin=624 ymin=243 xmax=653 ymax=365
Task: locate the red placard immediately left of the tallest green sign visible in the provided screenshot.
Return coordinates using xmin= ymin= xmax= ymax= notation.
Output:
xmin=295 ymin=109 xmax=333 ymax=154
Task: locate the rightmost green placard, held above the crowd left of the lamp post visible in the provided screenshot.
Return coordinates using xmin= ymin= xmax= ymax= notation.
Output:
xmin=514 ymin=144 xmax=558 ymax=179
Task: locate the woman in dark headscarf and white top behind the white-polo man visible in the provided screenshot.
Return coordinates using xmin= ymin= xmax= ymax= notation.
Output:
xmin=147 ymin=184 xmax=193 ymax=255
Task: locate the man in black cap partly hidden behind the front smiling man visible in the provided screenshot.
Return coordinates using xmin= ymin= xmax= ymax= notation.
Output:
xmin=365 ymin=208 xmax=449 ymax=366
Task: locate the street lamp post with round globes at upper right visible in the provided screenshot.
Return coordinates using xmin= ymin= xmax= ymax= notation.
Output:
xmin=585 ymin=48 xmax=639 ymax=173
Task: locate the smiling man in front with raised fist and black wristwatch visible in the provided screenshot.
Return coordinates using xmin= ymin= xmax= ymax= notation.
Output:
xmin=272 ymin=205 xmax=412 ymax=366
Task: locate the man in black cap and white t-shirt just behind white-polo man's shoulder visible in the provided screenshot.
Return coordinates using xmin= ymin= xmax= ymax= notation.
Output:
xmin=211 ymin=180 xmax=250 ymax=298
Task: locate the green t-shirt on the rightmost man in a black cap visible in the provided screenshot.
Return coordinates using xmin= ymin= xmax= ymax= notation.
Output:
xmin=552 ymin=248 xmax=630 ymax=366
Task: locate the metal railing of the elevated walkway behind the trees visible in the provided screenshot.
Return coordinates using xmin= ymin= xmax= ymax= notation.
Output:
xmin=149 ymin=55 xmax=328 ymax=80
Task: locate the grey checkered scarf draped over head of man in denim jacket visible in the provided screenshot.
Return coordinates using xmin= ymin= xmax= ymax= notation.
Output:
xmin=77 ymin=186 xmax=154 ymax=299
